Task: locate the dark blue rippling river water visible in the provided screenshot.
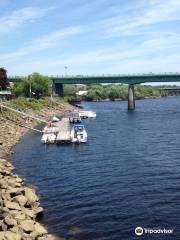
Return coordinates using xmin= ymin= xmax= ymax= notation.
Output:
xmin=13 ymin=97 xmax=180 ymax=240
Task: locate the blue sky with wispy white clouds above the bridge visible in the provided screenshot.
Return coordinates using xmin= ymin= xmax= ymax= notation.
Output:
xmin=0 ymin=0 xmax=180 ymax=75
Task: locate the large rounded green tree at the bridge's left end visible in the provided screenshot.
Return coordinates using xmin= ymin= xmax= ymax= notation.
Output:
xmin=12 ymin=73 xmax=52 ymax=98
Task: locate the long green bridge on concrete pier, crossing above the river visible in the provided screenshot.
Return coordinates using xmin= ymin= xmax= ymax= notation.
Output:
xmin=8 ymin=72 xmax=180 ymax=110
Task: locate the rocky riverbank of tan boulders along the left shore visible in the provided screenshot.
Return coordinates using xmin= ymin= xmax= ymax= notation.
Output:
xmin=0 ymin=98 xmax=73 ymax=240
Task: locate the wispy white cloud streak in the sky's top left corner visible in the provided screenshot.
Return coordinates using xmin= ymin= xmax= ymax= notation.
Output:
xmin=0 ymin=7 xmax=53 ymax=34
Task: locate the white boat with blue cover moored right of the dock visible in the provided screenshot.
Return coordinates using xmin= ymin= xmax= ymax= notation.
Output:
xmin=71 ymin=124 xmax=87 ymax=143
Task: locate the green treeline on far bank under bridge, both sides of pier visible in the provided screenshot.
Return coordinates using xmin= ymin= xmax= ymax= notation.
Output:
xmin=83 ymin=84 xmax=167 ymax=101
